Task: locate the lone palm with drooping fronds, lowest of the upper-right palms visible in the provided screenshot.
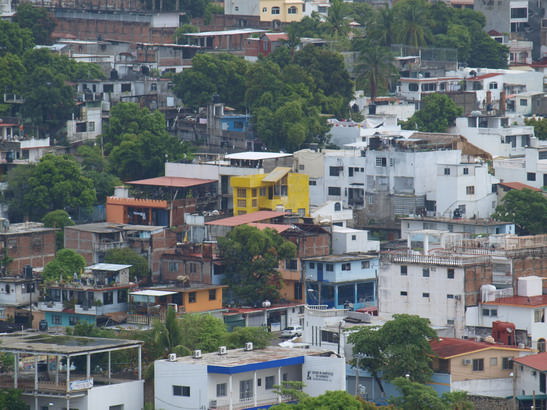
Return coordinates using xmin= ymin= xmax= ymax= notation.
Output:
xmin=357 ymin=43 xmax=397 ymax=102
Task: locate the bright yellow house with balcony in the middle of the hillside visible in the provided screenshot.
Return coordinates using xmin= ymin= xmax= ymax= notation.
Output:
xmin=230 ymin=167 xmax=310 ymax=216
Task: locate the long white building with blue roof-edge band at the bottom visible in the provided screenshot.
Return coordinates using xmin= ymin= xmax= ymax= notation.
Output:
xmin=154 ymin=343 xmax=346 ymax=410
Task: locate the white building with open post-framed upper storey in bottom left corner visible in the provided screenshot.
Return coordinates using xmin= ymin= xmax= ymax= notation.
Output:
xmin=0 ymin=333 xmax=144 ymax=410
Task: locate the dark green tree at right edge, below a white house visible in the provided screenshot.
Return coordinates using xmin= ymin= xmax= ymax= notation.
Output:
xmin=492 ymin=189 xmax=547 ymax=235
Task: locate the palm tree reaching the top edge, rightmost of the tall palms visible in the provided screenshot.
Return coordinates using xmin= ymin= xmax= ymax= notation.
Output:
xmin=394 ymin=0 xmax=431 ymax=47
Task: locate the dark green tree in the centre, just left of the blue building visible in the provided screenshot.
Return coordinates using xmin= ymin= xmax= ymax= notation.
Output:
xmin=218 ymin=225 xmax=296 ymax=305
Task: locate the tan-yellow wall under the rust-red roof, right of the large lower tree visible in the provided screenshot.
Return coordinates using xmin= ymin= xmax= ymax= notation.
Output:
xmin=444 ymin=349 xmax=519 ymax=381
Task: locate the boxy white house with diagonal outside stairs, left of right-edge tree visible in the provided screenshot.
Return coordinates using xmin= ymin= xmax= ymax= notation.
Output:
xmin=436 ymin=161 xmax=499 ymax=218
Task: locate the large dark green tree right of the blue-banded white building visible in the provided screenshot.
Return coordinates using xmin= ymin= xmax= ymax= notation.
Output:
xmin=349 ymin=314 xmax=436 ymax=391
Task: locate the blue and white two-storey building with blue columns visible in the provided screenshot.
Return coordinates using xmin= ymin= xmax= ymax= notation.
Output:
xmin=303 ymin=253 xmax=379 ymax=309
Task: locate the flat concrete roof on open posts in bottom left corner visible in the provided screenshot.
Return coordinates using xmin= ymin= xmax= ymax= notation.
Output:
xmin=0 ymin=333 xmax=143 ymax=356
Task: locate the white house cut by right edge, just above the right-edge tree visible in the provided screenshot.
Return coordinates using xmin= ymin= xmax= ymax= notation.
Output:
xmin=494 ymin=144 xmax=547 ymax=189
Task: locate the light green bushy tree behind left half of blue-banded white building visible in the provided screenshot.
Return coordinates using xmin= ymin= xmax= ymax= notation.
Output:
xmin=180 ymin=313 xmax=227 ymax=352
